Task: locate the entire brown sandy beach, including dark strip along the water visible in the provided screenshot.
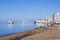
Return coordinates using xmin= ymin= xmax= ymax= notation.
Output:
xmin=0 ymin=26 xmax=60 ymax=40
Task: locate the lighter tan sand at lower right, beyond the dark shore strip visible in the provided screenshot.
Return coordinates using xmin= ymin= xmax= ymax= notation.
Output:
xmin=21 ymin=27 xmax=60 ymax=40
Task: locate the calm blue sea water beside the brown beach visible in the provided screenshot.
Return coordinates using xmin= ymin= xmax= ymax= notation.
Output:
xmin=0 ymin=23 xmax=36 ymax=36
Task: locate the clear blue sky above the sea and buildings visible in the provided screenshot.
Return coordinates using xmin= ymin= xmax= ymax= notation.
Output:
xmin=0 ymin=0 xmax=60 ymax=20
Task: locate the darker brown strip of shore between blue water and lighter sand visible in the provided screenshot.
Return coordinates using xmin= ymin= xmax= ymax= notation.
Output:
xmin=0 ymin=28 xmax=45 ymax=40
